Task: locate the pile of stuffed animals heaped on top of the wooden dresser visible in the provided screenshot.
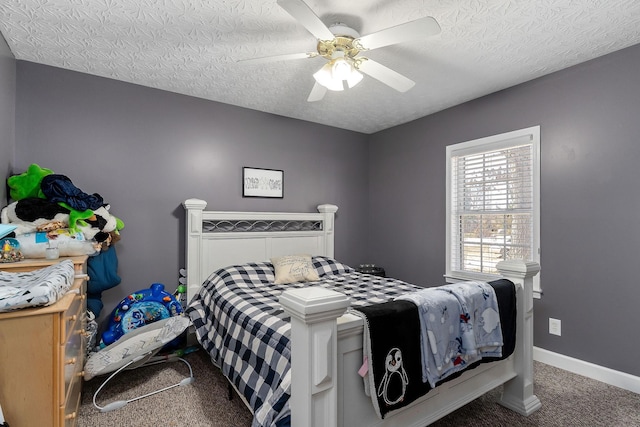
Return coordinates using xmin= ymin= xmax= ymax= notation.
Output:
xmin=0 ymin=163 xmax=124 ymax=258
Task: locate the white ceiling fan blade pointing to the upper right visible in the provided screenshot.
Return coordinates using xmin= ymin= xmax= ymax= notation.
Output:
xmin=354 ymin=16 xmax=440 ymax=50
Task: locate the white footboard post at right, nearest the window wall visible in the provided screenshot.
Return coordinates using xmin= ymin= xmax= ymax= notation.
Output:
xmin=496 ymin=260 xmax=542 ymax=416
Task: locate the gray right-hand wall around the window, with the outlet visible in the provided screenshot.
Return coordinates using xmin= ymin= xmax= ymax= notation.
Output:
xmin=369 ymin=46 xmax=640 ymax=375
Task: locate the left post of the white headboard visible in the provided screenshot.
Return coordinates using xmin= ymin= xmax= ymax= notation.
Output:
xmin=182 ymin=199 xmax=207 ymax=301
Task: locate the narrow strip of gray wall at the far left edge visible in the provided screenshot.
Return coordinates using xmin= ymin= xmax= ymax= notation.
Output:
xmin=0 ymin=34 xmax=16 ymax=206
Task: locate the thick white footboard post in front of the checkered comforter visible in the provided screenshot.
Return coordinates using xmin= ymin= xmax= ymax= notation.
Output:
xmin=280 ymin=287 xmax=350 ymax=427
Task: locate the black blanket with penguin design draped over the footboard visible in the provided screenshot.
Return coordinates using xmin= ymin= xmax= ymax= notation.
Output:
xmin=352 ymin=279 xmax=516 ymax=418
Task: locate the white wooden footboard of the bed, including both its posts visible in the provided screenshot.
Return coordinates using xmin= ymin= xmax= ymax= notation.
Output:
xmin=281 ymin=260 xmax=541 ymax=427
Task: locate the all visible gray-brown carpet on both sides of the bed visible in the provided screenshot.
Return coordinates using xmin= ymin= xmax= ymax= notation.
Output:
xmin=78 ymin=351 xmax=640 ymax=427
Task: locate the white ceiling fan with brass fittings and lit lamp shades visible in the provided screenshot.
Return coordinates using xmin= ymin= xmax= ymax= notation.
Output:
xmin=239 ymin=0 xmax=440 ymax=102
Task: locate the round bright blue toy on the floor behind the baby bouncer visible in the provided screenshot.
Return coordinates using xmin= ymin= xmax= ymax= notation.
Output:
xmin=100 ymin=283 xmax=182 ymax=348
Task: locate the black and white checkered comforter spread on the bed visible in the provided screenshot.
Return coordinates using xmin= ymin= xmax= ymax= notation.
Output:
xmin=186 ymin=257 xmax=420 ymax=427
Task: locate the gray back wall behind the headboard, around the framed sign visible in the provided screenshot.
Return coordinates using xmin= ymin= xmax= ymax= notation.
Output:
xmin=15 ymin=61 xmax=368 ymax=324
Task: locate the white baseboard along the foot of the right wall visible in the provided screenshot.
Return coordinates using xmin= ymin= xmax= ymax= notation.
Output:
xmin=533 ymin=347 xmax=640 ymax=394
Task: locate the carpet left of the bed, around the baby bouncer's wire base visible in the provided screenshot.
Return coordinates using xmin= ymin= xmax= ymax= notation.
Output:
xmin=78 ymin=350 xmax=251 ymax=427
